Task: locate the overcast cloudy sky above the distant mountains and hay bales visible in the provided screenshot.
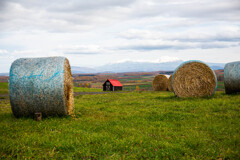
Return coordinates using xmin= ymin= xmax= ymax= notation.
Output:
xmin=0 ymin=0 xmax=240 ymax=72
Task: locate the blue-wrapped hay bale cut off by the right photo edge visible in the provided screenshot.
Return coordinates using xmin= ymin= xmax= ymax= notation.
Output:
xmin=224 ymin=61 xmax=240 ymax=94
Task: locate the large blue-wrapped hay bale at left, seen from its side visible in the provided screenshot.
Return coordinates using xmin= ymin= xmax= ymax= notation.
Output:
xmin=9 ymin=57 xmax=74 ymax=117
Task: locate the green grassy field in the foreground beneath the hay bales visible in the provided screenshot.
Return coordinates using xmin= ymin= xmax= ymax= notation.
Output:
xmin=0 ymin=91 xmax=240 ymax=159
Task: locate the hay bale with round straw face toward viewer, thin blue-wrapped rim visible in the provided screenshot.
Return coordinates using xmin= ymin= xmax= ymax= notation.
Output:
xmin=171 ymin=61 xmax=217 ymax=97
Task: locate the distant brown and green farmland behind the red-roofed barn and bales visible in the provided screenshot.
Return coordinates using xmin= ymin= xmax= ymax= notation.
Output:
xmin=0 ymin=70 xmax=223 ymax=90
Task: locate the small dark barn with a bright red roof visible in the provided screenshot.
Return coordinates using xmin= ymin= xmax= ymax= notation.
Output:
xmin=103 ymin=79 xmax=123 ymax=91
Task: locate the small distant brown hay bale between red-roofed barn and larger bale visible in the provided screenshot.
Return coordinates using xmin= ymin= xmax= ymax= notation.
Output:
xmin=152 ymin=74 xmax=168 ymax=91
